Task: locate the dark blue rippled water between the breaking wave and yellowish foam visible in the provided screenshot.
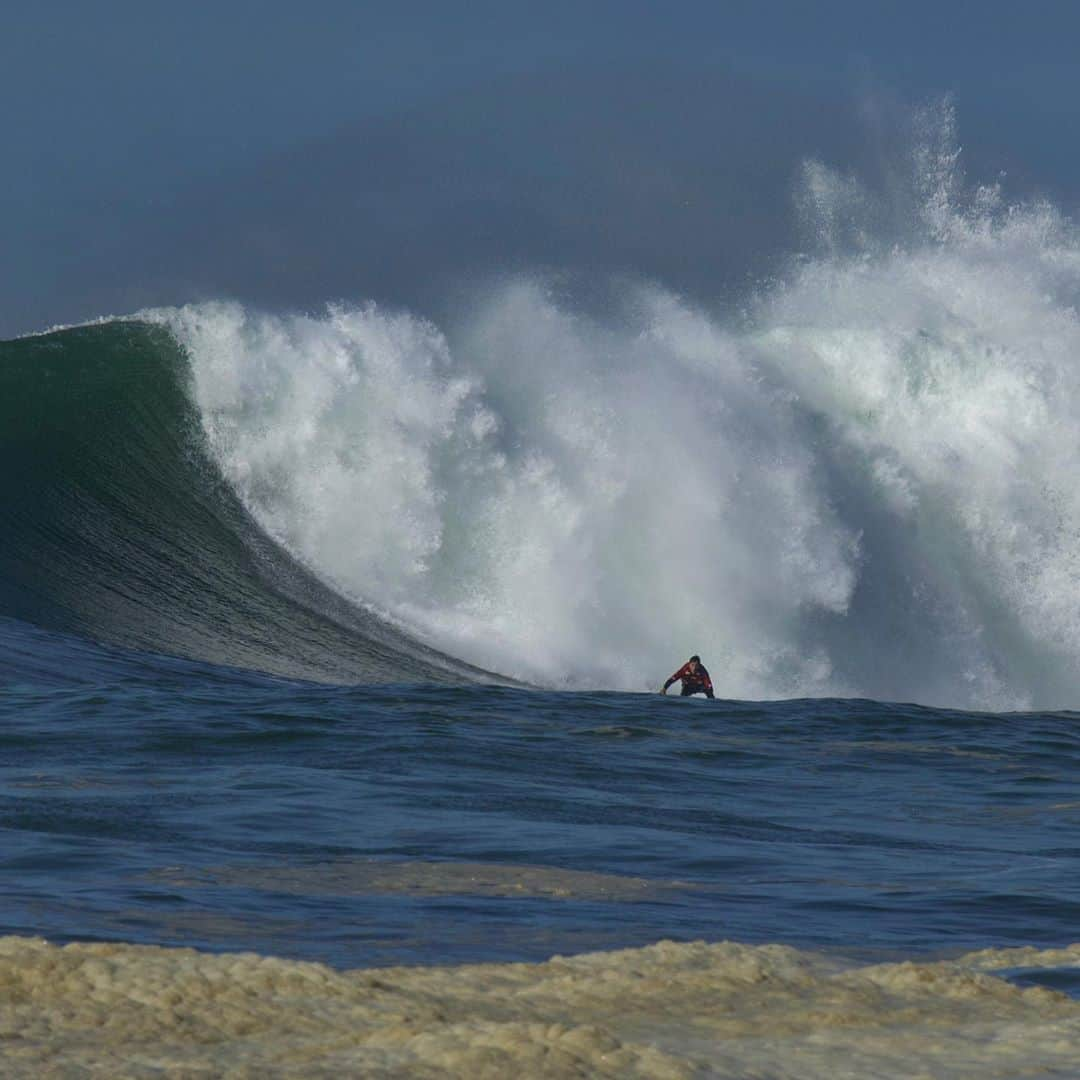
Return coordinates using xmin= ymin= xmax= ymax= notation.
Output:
xmin=0 ymin=620 xmax=1080 ymax=967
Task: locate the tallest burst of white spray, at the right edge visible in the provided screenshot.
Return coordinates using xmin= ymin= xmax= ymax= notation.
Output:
xmin=752 ymin=107 xmax=1080 ymax=708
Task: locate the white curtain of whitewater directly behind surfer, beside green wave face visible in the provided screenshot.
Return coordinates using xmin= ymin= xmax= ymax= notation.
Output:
xmin=156 ymin=282 xmax=856 ymax=696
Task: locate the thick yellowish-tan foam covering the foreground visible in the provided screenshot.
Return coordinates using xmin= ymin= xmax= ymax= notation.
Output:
xmin=0 ymin=937 xmax=1080 ymax=1080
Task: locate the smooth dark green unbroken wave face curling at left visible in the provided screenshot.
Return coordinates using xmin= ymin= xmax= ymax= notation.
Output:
xmin=0 ymin=322 xmax=494 ymax=683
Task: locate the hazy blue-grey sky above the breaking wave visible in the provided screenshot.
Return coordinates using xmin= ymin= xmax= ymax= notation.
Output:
xmin=0 ymin=0 xmax=1080 ymax=336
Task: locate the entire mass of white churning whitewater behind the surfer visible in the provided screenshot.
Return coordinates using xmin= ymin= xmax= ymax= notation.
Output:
xmin=151 ymin=103 xmax=1080 ymax=708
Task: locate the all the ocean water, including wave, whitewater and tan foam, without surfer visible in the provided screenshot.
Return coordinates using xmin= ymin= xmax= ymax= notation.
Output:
xmin=0 ymin=103 xmax=1080 ymax=1077
